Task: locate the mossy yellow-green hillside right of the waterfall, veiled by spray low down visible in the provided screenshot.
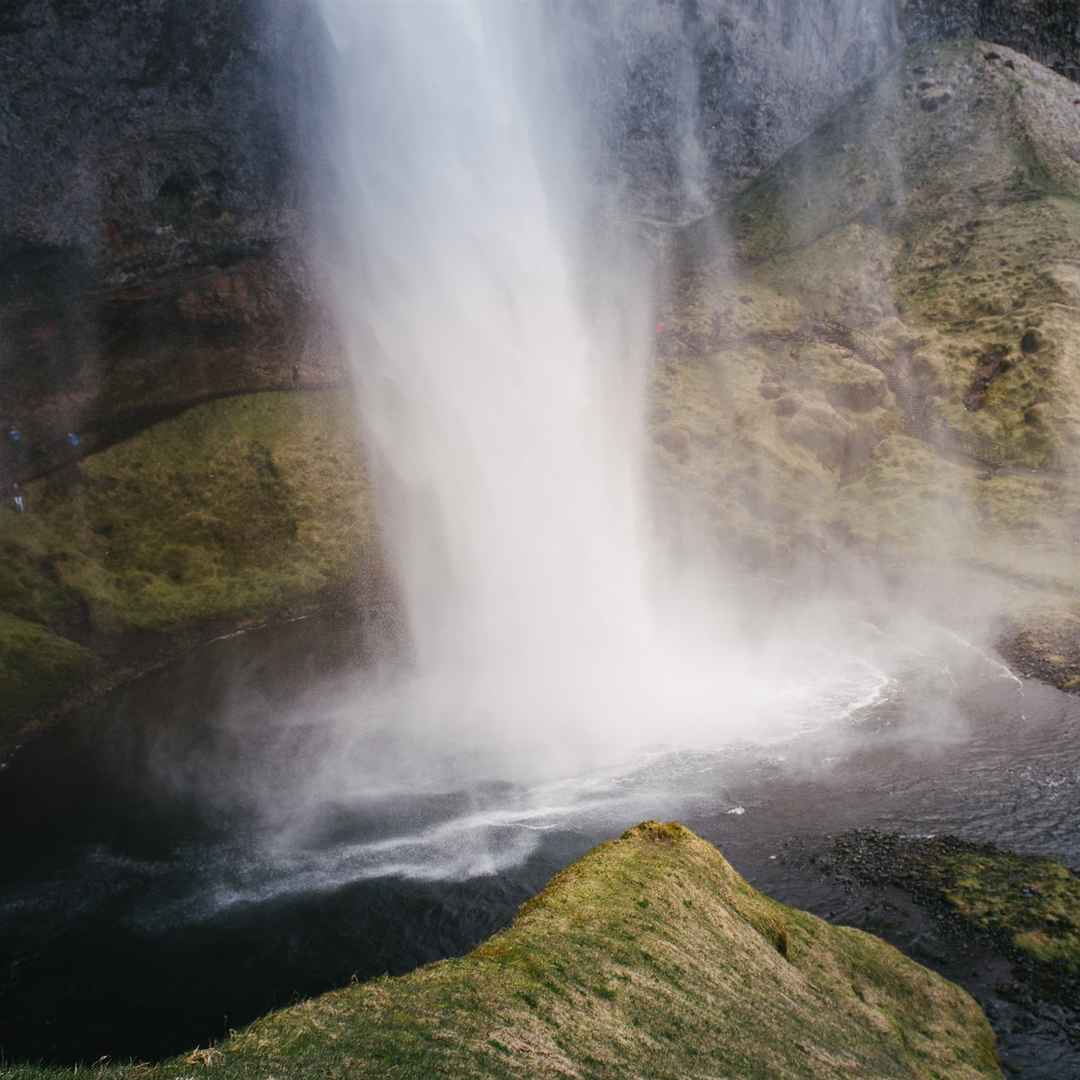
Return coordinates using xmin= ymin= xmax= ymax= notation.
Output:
xmin=653 ymin=41 xmax=1080 ymax=607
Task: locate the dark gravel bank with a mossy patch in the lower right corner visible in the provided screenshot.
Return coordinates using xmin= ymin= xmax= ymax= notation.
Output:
xmin=783 ymin=831 xmax=1080 ymax=1078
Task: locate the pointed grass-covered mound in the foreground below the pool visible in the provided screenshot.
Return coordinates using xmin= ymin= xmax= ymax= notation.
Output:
xmin=5 ymin=822 xmax=1001 ymax=1080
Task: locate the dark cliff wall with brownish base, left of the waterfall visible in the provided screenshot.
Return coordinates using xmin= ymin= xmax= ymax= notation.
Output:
xmin=0 ymin=0 xmax=340 ymax=460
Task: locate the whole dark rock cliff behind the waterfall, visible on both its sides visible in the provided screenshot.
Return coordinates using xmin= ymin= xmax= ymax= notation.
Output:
xmin=0 ymin=0 xmax=1078 ymax=460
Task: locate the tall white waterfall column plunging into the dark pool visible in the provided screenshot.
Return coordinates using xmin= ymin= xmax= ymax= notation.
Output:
xmin=306 ymin=0 xmax=894 ymax=789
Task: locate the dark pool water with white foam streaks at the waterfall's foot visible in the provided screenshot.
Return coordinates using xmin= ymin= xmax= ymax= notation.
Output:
xmin=0 ymin=619 xmax=1080 ymax=1078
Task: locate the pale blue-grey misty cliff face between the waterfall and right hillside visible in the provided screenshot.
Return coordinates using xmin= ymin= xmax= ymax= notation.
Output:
xmin=578 ymin=0 xmax=901 ymax=220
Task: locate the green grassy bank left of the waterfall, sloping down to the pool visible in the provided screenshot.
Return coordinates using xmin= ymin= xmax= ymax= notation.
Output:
xmin=0 ymin=393 xmax=378 ymax=751
